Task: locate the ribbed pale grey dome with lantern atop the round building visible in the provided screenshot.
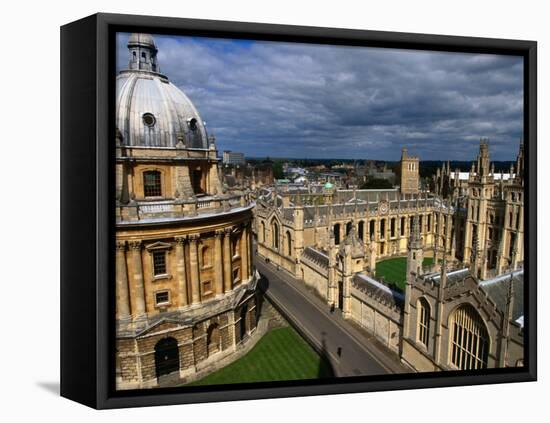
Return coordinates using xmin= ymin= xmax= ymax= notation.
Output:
xmin=116 ymin=34 xmax=208 ymax=149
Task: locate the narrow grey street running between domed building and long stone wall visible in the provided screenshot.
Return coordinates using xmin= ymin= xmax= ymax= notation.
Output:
xmin=255 ymin=257 xmax=410 ymax=377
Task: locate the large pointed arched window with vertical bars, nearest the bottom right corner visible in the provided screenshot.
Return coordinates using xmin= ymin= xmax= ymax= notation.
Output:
xmin=449 ymin=305 xmax=489 ymax=370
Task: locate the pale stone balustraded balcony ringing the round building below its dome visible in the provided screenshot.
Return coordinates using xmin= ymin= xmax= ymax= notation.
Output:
xmin=116 ymin=194 xmax=255 ymax=226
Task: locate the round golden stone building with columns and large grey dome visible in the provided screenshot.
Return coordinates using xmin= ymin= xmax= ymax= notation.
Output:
xmin=116 ymin=34 xmax=259 ymax=389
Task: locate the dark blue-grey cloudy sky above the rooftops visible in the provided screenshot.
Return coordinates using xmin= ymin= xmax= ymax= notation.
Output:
xmin=117 ymin=34 xmax=523 ymax=160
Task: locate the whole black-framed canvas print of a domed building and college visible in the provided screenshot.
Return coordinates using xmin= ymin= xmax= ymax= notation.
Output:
xmin=61 ymin=14 xmax=537 ymax=408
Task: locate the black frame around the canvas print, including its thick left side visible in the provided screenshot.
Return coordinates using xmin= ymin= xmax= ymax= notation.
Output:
xmin=61 ymin=13 xmax=537 ymax=409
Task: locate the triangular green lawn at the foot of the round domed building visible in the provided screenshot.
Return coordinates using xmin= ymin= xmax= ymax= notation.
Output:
xmin=189 ymin=327 xmax=334 ymax=386
